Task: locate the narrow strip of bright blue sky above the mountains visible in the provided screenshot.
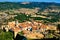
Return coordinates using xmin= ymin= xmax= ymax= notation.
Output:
xmin=0 ymin=0 xmax=60 ymax=3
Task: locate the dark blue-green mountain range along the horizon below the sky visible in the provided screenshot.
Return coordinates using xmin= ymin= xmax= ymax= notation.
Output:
xmin=0 ymin=2 xmax=60 ymax=10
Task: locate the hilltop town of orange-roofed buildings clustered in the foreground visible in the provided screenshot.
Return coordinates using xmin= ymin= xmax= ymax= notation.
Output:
xmin=2 ymin=21 xmax=57 ymax=38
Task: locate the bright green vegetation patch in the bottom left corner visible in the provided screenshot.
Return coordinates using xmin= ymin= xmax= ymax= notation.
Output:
xmin=0 ymin=31 xmax=13 ymax=40
